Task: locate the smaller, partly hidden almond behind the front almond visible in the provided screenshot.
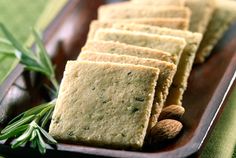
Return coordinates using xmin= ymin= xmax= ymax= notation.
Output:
xmin=158 ymin=105 xmax=185 ymax=120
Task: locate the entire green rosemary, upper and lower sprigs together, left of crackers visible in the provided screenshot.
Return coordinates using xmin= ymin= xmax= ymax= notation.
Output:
xmin=0 ymin=23 xmax=59 ymax=153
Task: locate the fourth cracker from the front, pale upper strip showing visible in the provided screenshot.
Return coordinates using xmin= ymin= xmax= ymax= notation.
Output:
xmin=94 ymin=29 xmax=186 ymax=65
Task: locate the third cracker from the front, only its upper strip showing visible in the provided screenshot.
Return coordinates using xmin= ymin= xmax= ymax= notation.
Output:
xmin=82 ymin=40 xmax=177 ymax=63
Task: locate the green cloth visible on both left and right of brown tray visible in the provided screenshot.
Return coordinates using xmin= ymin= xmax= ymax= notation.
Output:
xmin=0 ymin=0 xmax=236 ymax=158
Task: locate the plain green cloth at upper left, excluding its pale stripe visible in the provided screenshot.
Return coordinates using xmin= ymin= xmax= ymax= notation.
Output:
xmin=0 ymin=0 xmax=47 ymax=84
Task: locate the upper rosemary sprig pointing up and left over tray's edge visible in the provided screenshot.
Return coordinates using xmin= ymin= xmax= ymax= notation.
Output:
xmin=0 ymin=23 xmax=59 ymax=92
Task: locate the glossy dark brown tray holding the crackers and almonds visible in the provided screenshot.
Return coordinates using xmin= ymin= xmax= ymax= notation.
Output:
xmin=0 ymin=0 xmax=236 ymax=158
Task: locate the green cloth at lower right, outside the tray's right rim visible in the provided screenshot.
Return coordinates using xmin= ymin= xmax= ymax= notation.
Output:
xmin=201 ymin=90 xmax=236 ymax=158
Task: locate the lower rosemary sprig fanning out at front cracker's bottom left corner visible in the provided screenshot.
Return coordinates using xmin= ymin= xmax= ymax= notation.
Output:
xmin=0 ymin=100 xmax=57 ymax=154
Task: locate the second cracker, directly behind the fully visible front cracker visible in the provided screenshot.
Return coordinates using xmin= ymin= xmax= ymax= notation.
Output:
xmin=78 ymin=52 xmax=176 ymax=129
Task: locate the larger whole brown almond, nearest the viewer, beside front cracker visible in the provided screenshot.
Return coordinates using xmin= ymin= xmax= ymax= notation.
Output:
xmin=150 ymin=119 xmax=183 ymax=144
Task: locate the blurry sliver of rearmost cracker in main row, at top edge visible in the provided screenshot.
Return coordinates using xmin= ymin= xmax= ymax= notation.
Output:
xmin=131 ymin=0 xmax=185 ymax=7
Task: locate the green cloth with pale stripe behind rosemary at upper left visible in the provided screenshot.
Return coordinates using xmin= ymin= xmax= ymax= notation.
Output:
xmin=0 ymin=0 xmax=67 ymax=84
